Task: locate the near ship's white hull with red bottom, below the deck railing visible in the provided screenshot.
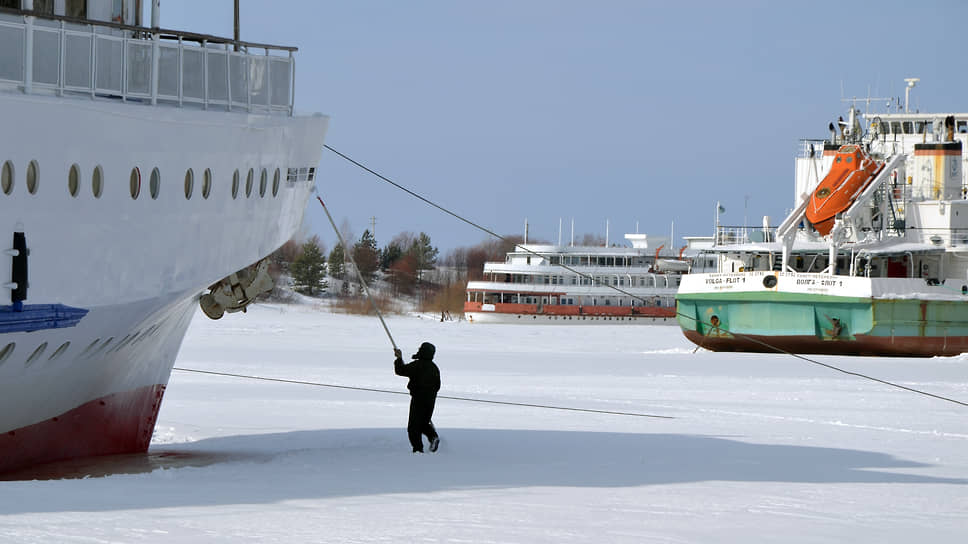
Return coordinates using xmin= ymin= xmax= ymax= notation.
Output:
xmin=0 ymin=94 xmax=327 ymax=471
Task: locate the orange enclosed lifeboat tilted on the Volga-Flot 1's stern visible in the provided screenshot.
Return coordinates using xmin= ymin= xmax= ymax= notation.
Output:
xmin=806 ymin=145 xmax=884 ymax=236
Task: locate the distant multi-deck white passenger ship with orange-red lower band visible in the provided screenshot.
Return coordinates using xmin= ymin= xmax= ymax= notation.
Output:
xmin=464 ymin=234 xmax=689 ymax=325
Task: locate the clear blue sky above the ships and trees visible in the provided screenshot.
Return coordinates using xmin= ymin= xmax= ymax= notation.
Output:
xmin=162 ymin=0 xmax=968 ymax=253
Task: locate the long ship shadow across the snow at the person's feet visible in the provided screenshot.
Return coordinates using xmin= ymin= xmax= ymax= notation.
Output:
xmin=0 ymin=428 xmax=968 ymax=512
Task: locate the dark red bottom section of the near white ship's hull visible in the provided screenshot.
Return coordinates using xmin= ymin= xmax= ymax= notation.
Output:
xmin=0 ymin=385 xmax=165 ymax=472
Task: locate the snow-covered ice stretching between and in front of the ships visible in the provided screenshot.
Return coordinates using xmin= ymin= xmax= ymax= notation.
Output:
xmin=0 ymin=305 xmax=968 ymax=543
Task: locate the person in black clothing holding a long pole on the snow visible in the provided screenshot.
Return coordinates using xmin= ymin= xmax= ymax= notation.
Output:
xmin=393 ymin=342 xmax=440 ymax=453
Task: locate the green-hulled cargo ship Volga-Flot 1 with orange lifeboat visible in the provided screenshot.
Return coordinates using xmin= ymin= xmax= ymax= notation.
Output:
xmin=676 ymin=78 xmax=968 ymax=357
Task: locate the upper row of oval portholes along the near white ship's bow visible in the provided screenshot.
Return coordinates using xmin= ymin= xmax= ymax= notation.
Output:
xmin=0 ymin=160 xmax=316 ymax=200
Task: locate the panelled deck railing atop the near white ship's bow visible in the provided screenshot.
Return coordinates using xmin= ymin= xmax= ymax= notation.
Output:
xmin=0 ymin=9 xmax=296 ymax=115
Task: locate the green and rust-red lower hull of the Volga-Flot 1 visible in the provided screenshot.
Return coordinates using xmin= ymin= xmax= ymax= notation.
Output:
xmin=676 ymin=291 xmax=968 ymax=357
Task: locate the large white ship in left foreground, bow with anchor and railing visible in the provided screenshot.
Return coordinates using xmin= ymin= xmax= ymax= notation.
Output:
xmin=0 ymin=0 xmax=328 ymax=471
